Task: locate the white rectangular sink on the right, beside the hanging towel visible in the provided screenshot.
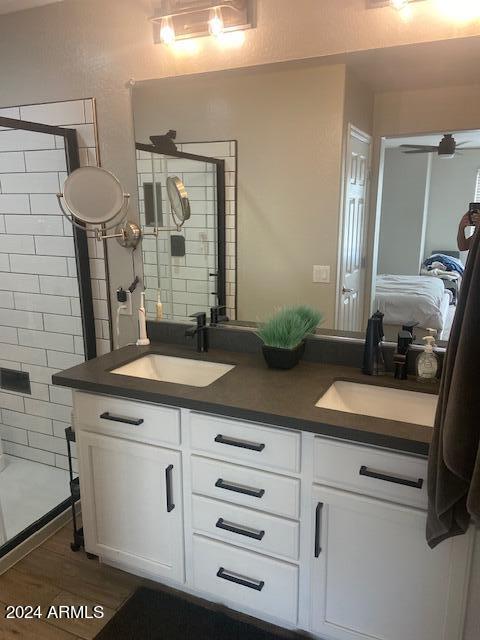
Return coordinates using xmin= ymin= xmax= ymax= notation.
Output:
xmin=315 ymin=380 xmax=438 ymax=427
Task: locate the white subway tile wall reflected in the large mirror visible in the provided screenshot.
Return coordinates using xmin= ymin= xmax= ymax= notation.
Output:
xmin=137 ymin=140 xmax=237 ymax=320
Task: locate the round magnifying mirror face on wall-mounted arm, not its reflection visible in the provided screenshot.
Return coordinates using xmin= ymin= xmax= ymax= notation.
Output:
xmin=63 ymin=167 xmax=128 ymax=224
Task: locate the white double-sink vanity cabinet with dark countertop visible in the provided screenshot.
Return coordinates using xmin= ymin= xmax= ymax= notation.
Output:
xmin=55 ymin=345 xmax=473 ymax=640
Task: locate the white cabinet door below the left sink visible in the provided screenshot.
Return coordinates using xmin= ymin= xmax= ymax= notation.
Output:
xmin=78 ymin=432 xmax=184 ymax=581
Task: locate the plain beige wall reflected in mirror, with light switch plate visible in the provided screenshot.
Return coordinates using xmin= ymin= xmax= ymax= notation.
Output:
xmin=134 ymin=63 xmax=345 ymax=327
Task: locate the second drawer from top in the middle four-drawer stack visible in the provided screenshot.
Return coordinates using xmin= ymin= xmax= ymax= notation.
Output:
xmin=192 ymin=456 xmax=300 ymax=518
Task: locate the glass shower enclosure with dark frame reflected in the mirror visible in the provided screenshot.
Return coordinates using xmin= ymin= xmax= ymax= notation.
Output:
xmin=136 ymin=143 xmax=226 ymax=321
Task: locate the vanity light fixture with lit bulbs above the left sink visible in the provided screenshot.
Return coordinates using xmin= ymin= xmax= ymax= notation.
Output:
xmin=150 ymin=0 xmax=255 ymax=45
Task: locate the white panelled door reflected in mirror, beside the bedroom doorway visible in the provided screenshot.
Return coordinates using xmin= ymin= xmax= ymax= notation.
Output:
xmin=336 ymin=125 xmax=372 ymax=331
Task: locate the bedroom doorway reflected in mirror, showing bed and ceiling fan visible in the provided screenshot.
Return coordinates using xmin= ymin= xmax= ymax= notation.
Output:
xmin=370 ymin=130 xmax=480 ymax=342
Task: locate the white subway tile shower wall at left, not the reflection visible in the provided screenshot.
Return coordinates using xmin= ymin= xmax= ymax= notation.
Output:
xmin=0 ymin=99 xmax=110 ymax=468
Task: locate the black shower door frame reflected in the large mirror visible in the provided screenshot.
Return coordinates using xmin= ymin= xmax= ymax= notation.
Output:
xmin=135 ymin=142 xmax=227 ymax=316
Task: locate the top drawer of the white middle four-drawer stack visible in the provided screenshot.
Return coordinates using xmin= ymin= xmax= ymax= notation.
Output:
xmin=190 ymin=413 xmax=301 ymax=473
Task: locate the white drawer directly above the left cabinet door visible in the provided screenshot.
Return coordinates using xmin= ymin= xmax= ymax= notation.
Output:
xmin=74 ymin=392 xmax=180 ymax=445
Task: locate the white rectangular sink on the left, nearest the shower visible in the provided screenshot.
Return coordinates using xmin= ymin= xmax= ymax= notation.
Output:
xmin=110 ymin=354 xmax=235 ymax=387
